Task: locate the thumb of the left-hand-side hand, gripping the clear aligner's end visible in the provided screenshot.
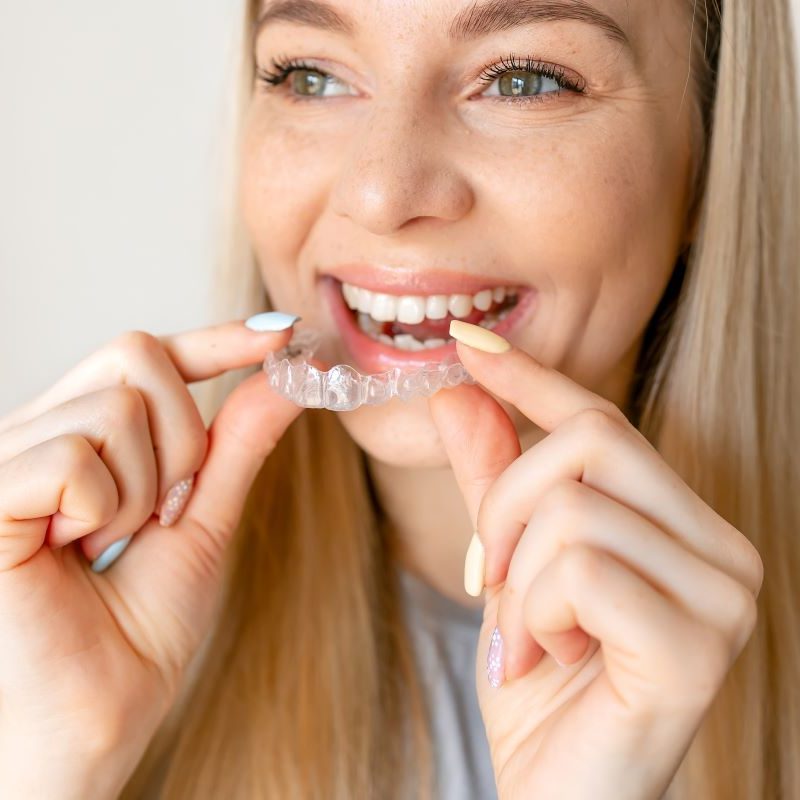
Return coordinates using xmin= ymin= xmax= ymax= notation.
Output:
xmin=183 ymin=371 xmax=304 ymax=541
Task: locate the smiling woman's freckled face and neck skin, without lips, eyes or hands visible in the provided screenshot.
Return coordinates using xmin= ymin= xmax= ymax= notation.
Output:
xmin=240 ymin=0 xmax=692 ymax=605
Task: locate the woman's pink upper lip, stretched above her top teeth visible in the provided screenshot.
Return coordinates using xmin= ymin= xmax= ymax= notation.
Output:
xmin=323 ymin=263 xmax=517 ymax=295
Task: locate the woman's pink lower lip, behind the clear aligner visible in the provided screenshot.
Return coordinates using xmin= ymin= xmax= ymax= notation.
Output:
xmin=322 ymin=276 xmax=536 ymax=373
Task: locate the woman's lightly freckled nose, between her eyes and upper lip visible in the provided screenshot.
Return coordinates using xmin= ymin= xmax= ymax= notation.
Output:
xmin=331 ymin=101 xmax=474 ymax=235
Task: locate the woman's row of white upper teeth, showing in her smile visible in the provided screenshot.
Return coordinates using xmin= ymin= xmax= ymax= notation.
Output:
xmin=342 ymin=283 xmax=516 ymax=325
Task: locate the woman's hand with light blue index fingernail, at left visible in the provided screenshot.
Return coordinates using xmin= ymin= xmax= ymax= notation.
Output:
xmin=0 ymin=321 xmax=302 ymax=800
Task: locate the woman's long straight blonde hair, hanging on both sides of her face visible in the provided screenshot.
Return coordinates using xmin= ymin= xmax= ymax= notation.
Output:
xmin=123 ymin=0 xmax=800 ymax=800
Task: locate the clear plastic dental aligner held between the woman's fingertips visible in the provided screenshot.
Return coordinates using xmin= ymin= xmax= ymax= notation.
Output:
xmin=263 ymin=328 xmax=475 ymax=411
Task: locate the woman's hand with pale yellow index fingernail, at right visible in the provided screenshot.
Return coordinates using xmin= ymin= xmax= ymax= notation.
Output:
xmin=430 ymin=328 xmax=763 ymax=800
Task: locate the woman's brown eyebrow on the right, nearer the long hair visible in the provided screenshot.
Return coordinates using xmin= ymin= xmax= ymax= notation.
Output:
xmin=450 ymin=0 xmax=631 ymax=47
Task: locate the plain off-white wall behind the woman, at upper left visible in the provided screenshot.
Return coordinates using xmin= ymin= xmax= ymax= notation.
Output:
xmin=0 ymin=0 xmax=800 ymax=415
